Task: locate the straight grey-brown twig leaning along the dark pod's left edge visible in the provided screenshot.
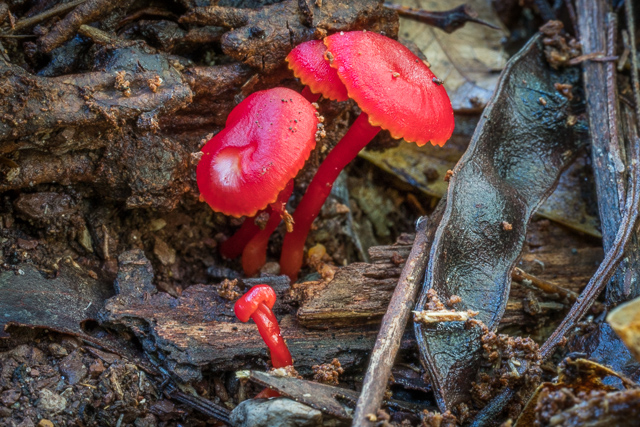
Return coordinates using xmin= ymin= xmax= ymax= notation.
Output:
xmin=353 ymin=217 xmax=431 ymax=426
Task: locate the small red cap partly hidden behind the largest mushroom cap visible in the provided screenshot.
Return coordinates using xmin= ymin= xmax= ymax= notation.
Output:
xmin=287 ymin=40 xmax=349 ymax=101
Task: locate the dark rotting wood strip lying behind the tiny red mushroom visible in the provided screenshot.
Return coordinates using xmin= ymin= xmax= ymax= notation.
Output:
xmin=100 ymin=251 xmax=404 ymax=382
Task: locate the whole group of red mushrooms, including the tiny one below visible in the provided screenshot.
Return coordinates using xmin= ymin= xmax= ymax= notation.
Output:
xmin=197 ymin=31 xmax=454 ymax=368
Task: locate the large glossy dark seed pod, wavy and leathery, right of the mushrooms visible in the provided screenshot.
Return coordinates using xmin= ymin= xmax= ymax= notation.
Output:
xmin=415 ymin=36 xmax=586 ymax=412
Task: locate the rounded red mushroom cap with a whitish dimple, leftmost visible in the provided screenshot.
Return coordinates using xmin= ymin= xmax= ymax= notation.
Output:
xmin=196 ymin=88 xmax=318 ymax=217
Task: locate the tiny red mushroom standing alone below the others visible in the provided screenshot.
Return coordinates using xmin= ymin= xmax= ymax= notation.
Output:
xmin=233 ymin=285 xmax=293 ymax=368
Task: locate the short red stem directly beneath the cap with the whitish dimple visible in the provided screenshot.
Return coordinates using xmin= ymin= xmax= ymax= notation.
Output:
xmin=242 ymin=180 xmax=293 ymax=277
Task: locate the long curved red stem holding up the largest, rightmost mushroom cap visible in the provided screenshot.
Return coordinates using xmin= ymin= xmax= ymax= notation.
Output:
xmin=280 ymin=113 xmax=380 ymax=282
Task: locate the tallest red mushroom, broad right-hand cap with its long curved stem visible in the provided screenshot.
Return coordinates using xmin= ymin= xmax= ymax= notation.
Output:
xmin=280 ymin=31 xmax=454 ymax=280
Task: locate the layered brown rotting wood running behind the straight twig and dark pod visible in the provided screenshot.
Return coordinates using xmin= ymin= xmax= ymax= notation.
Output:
xmin=292 ymin=220 xmax=602 ymax=329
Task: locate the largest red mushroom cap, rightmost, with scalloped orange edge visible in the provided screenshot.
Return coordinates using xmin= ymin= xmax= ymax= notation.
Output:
xmin=324 ymin=31 xmax=454 ymax=146
